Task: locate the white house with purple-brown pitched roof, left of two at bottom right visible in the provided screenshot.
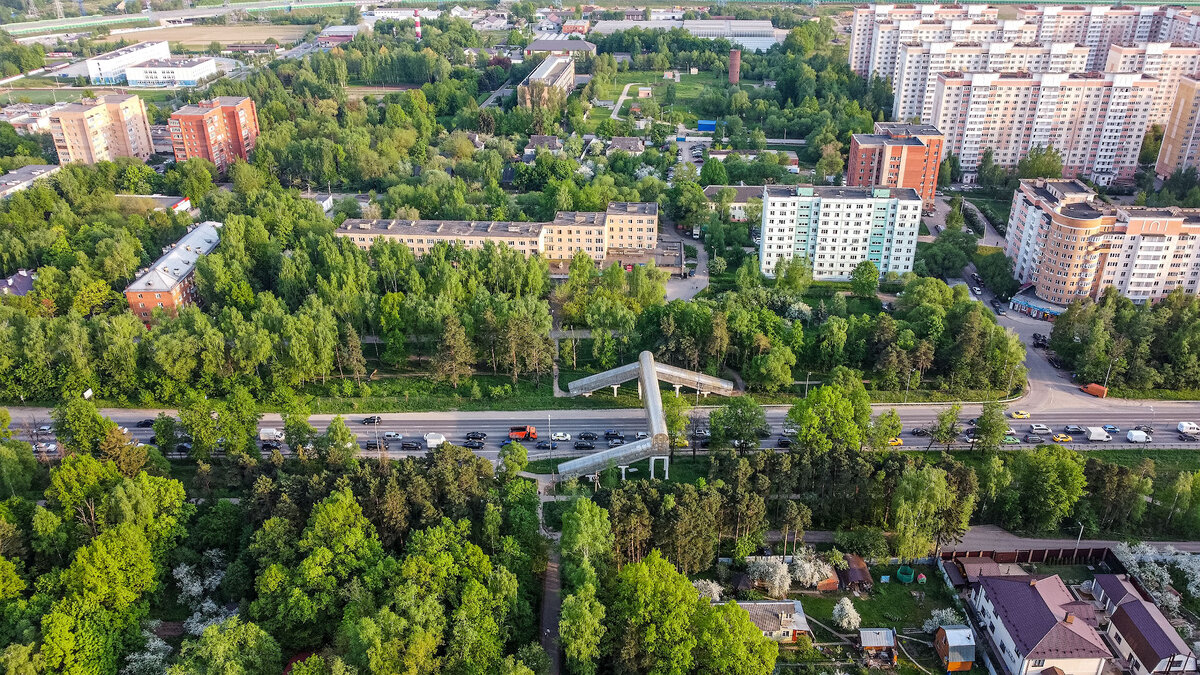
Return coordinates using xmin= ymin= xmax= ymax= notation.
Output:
xmin=970 ymin=574 xmax=1112 ymax=675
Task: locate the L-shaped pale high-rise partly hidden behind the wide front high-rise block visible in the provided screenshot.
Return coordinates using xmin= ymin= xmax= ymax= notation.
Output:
xmin=892 ymin=42 xmax=1088 ymax=124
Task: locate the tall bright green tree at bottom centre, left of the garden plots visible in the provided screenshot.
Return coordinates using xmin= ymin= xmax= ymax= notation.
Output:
xmin=608 ymin=550 xmax=697 ymax=673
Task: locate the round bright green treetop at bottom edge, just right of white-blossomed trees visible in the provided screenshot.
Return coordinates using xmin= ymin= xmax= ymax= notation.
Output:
xmin=168 ymin=616 xmax=283 ymax=675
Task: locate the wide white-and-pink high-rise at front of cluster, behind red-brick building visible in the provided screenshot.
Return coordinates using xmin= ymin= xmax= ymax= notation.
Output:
xmin=931 ymin=72 xmax=1158 ymax=185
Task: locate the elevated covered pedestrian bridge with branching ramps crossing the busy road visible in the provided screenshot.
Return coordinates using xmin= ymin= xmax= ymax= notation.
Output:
xmin=558 ymin=352 xmax=733 ymax=479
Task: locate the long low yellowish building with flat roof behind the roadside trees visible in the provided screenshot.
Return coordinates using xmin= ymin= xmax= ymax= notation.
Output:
xmin=337 ymin=202 xmax=659 ymax=261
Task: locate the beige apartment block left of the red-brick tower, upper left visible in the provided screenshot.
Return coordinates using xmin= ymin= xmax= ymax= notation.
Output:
xmin=50 ymin=95 xmax=154 ymax=165
